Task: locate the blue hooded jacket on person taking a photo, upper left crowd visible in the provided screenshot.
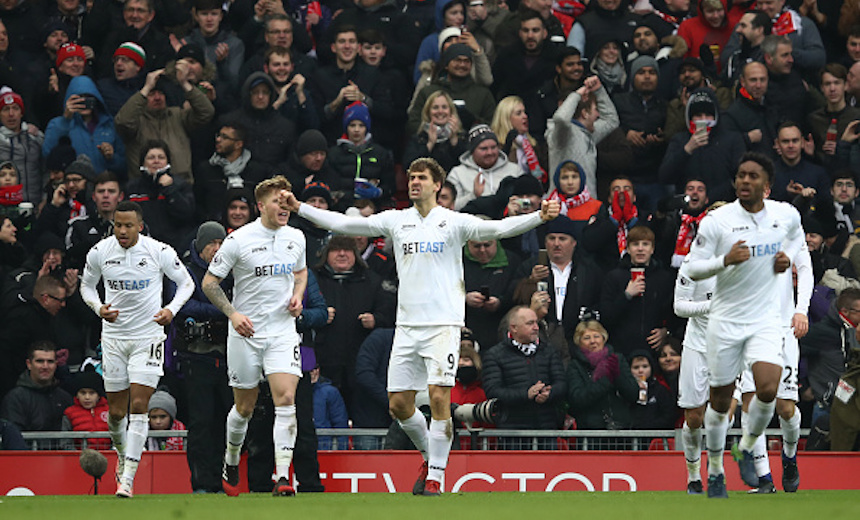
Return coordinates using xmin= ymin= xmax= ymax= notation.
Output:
xmin=42 ymin=76 xmax=126 ymax=178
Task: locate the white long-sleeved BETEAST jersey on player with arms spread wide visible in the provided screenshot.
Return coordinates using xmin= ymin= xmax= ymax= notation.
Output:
xmin=299 ymin=204 xmax=542 ymax=326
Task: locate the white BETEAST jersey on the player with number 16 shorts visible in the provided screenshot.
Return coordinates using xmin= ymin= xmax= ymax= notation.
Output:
xmin=81 ymin=235 xmax=194 ymax=340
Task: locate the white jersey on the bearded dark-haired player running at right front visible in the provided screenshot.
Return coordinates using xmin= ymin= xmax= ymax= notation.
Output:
xmin=684 ymin=200 xmax=805 ymax=324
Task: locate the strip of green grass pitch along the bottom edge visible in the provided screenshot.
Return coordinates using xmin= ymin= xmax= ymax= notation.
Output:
xmin=0 ymin=490 xmax=860 ymax=520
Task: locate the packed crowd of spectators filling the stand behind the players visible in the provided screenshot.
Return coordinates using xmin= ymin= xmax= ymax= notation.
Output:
xmin=0 ymin=0 xmax=860 ymax=458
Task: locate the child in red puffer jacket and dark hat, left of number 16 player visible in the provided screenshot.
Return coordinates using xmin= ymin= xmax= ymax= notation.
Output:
xmin=63 ymin=370 xmax=110 ymax=450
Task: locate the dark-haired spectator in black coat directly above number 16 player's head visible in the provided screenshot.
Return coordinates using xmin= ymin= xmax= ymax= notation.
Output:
xmin=126 ymin=140 xmax=194 ymax=254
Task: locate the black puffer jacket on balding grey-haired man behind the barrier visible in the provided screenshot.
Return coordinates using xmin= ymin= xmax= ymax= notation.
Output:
xmin=483 ymin=339 xmax=568 ymax=430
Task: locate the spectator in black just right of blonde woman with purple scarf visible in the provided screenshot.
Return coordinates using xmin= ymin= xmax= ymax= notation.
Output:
xmin=627 ymin=350 xmax=678 ymax=430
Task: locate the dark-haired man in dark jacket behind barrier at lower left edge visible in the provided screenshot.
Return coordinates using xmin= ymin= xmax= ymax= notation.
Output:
xmin=0 ymin=341 xmax=73 ymax=432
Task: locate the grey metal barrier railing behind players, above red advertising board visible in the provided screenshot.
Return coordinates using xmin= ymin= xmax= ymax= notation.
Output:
xmin=22 ymin=428 xmax=809 ymax=451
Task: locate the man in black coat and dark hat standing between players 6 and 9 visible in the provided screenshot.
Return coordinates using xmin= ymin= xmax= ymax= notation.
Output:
xmin=309 ymin=236 xmax=395 ymax=418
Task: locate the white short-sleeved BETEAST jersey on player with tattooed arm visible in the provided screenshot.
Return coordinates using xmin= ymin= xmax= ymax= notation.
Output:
xmin=209 ymin=218 xmax=306 ymax=338
